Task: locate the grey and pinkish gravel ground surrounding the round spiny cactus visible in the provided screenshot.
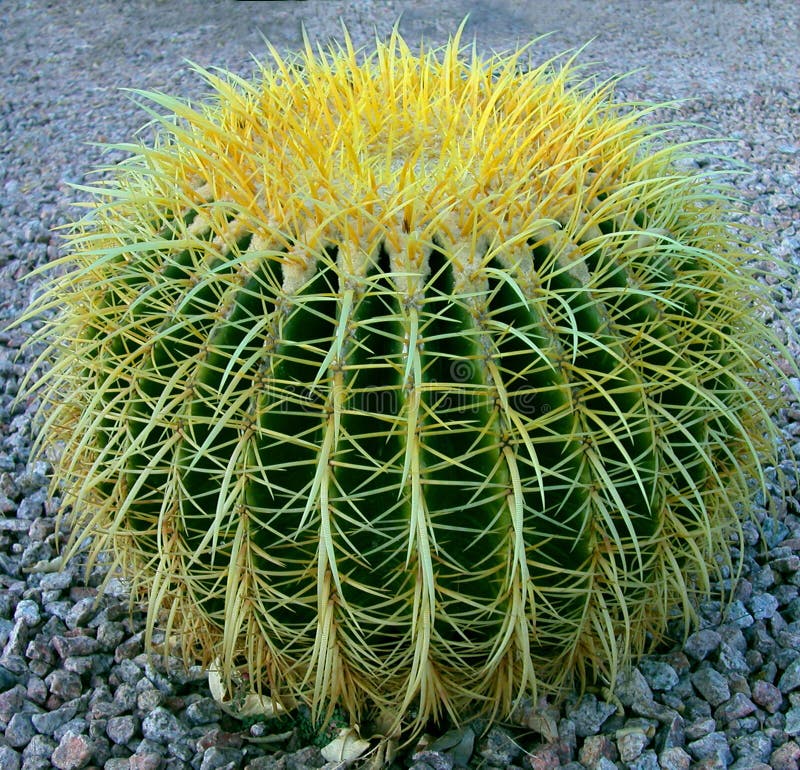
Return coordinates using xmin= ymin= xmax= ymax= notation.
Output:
xmin=0 ymin=0 xmax=800 ymax=770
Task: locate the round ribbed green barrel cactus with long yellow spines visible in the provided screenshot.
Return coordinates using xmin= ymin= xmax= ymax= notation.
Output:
xmin=21 ymin=28 xmax=783 ymax=727
